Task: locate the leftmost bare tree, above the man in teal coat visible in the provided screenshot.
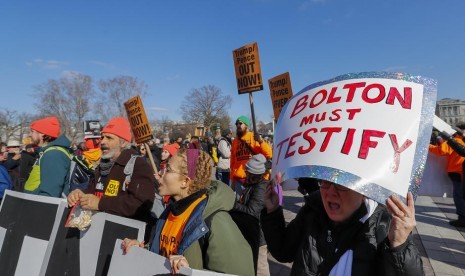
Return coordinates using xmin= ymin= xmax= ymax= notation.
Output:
xmin=35 ymin=73 xmax=94 ymax=141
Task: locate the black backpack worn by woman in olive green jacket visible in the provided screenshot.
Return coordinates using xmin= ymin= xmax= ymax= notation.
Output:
xmin=199 ymin=210 xmax=260 ymax=273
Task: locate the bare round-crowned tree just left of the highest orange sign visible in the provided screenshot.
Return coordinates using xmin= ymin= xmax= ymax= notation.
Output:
xmin=181 ymin=85 xmax=232 ymax=129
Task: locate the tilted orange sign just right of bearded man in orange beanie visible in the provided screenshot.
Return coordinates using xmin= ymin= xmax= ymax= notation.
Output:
xmin=124 ymin=96 xmax=153 ymax=144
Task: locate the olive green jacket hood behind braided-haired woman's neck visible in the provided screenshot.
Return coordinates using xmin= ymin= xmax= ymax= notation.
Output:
xmin=203 ymin=180 xmax=236 ymax=218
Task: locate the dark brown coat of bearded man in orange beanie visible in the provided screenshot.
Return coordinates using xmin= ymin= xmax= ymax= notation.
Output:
xmin=83 ymin=149 xmax=158 ymax=237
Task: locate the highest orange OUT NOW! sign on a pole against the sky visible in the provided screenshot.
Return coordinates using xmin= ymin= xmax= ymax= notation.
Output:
xmin=233 ymin=42 xmax=263 ymax=94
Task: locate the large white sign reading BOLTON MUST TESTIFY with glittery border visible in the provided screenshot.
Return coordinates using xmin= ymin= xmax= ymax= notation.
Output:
xmin=273 ymin=72 xmax=436 ymax=204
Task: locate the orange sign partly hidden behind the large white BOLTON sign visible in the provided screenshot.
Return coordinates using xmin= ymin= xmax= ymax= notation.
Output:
xmin=268 ymin=72 xmax=293 ymax=121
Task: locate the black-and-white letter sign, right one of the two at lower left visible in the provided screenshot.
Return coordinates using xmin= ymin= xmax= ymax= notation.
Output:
xmin=41 ymin=211 xmax=145 ymax=275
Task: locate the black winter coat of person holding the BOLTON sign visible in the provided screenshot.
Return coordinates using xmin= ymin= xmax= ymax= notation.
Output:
xmin=261 ymin=191 xmax=423 ymax=276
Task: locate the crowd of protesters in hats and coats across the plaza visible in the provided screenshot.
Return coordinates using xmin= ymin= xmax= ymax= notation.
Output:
xmin=0 ymin=113 xmax=454 ymax=275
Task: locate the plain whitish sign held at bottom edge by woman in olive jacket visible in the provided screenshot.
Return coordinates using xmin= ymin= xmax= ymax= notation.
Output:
xmin=108 ymin=240 xmax=234 ymax=276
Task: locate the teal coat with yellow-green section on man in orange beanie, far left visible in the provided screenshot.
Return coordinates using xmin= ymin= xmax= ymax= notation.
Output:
xmin=24 ymin=135 xmax=71 ymax=197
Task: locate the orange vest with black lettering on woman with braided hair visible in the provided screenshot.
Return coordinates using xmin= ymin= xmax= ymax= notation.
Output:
xmin=160 ymin=195 xmax=207 ymax=258
